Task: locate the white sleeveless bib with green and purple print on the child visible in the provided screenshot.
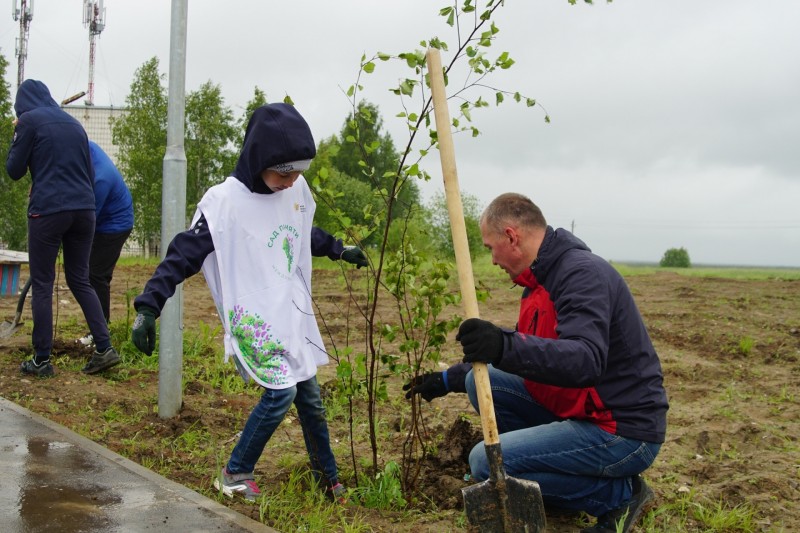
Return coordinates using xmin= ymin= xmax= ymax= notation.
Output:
xmin=195 ymin=176 xmax=328 ymax=389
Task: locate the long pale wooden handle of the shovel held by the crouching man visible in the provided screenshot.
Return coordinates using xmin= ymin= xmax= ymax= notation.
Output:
xmin=427 ymin=48 xmax=500 ymax=445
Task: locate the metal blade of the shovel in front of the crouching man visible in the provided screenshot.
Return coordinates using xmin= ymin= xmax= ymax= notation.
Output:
xmin=461 ymin=477 xmax=546 ymax=533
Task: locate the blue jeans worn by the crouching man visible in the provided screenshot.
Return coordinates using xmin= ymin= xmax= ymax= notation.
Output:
xmin=466 ymin=365 xmax=661 ymax=516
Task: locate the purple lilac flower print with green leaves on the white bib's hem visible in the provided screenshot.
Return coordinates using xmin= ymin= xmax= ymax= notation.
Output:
xmin=228 ymin=305 xmax=289 ymax=385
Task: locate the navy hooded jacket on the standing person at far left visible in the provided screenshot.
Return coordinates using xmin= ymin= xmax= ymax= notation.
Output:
xmin=6 ymin=80 xmax=95 ymax=217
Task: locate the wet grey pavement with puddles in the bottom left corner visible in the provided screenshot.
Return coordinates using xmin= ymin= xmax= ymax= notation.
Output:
xmin=0 ymin=397 xmax=278 ymax=533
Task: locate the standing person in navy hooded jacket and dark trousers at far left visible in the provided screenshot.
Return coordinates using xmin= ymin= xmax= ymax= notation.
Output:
xmin=6 ymin=79 xmax=120 ymax=377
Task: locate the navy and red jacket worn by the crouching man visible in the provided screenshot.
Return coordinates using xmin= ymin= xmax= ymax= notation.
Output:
xmin=446 ymin=226 xmax=669 ymax=443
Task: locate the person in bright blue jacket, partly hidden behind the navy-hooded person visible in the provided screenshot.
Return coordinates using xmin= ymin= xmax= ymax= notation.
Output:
xmin=80 ymin=140 xmax=133 ymax=346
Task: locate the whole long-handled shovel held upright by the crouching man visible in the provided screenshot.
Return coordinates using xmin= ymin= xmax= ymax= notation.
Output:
xmin=427 ymin=48 xmax=546 ymax=533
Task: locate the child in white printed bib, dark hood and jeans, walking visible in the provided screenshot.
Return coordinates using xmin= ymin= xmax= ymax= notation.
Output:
xmin=132 ymin=103 xmax=368 ymax=502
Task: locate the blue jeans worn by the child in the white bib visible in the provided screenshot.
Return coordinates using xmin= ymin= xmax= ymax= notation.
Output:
xmin=228 ymin=376 xmax=339 ymax=485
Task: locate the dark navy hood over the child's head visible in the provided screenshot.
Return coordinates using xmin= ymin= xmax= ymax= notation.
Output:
xmin=233 ymin=103 xmax=317 ymax=191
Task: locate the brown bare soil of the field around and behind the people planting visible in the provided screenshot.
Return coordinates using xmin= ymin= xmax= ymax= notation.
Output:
xmin=0 ymin=267 xmax=800 ymax=533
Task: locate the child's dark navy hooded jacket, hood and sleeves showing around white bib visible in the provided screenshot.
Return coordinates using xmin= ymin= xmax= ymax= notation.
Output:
xmin=134 ymin=103 xmax=344 ymax=313
